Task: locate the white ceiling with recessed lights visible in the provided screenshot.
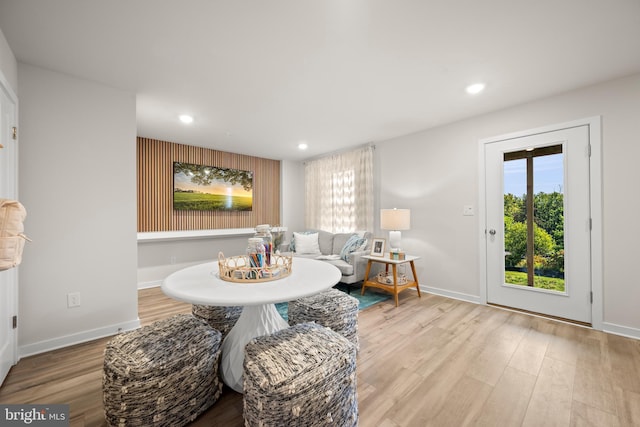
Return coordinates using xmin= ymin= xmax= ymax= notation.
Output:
xmin=0 ymin=0 xmax=640 ymax=160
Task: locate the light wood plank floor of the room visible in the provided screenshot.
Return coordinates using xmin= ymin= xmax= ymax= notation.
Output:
xmin=0 ymin=289 xmax=640 ymax=427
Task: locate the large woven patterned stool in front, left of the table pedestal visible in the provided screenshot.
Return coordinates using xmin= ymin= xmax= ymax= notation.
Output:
xmin=102 ymin=314 xmax=222 ymax=427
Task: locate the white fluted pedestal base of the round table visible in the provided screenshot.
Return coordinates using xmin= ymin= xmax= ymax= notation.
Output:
xmin=220 ymin=304 xmax=289 ymax=393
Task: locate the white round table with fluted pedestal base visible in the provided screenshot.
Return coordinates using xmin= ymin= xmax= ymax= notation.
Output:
xmin=162 ymin=258 xmax=342 ymax=393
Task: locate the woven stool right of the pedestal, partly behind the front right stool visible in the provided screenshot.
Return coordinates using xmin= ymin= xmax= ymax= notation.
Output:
xmin=288 ymin=289 xmax=360 ymax=350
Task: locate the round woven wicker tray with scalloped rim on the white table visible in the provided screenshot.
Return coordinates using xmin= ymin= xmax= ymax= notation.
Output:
xmin=218 ymin=252 xmax=293 ymax=283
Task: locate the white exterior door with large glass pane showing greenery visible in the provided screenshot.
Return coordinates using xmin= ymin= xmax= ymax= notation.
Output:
xmin=484 ymin=125 xmax=592 ymax=324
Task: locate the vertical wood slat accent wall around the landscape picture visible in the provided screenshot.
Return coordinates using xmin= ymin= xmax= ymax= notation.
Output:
xmin=137 ymin=137 xmax=280 ymax=232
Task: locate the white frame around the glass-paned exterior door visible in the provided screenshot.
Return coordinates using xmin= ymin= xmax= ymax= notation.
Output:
xmin=478 ymin=116 xmax=604 ymax=331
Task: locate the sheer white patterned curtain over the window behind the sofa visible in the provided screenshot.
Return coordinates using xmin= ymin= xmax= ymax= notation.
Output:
xmin=304 ymin=146 xmax=374 ymax=233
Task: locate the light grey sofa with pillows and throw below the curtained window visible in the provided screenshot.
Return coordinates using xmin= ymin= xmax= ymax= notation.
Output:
xmin=284 ymin=230 xmax=373 ymax=284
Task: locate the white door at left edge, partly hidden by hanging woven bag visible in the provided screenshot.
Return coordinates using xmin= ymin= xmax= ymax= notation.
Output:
xmin=0 ymin=75 xmax=18 ymax=384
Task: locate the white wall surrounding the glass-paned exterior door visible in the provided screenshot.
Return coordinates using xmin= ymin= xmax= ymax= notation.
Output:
xmin=376 ymin=74 xmax=640 ymax=338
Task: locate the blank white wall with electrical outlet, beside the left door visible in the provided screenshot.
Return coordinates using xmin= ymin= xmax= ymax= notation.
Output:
xmin=18 ymin=63 xmax=139 ymax=356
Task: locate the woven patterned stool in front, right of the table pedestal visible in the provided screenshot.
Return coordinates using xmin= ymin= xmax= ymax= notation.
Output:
xmin=243 ymin=323 xmax=358 ymax=427
